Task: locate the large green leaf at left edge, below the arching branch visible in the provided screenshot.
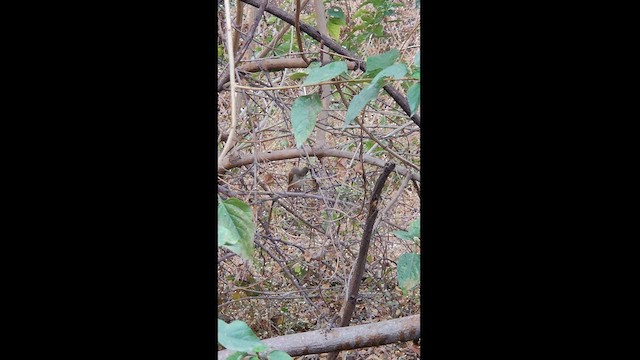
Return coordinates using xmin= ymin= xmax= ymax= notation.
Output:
xmin=218 ymin=198 xmax=255 ymax=261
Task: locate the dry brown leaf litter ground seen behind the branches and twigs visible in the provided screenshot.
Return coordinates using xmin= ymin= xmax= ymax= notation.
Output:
xmin=217 ymin=1 xmax=420 ymax=359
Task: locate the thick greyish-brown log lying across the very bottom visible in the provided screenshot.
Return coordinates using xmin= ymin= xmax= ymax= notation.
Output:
xmin=218 ymin=315 xmax=420 ymax=360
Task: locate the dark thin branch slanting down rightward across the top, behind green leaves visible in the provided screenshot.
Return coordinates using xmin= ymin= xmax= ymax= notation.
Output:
xmin=234 ymin=0 xmax=420 ymax=126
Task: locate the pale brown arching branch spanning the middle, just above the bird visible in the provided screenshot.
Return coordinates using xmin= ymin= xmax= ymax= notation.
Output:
xmin=218 ymin=146 xmax=420 ymax=181
